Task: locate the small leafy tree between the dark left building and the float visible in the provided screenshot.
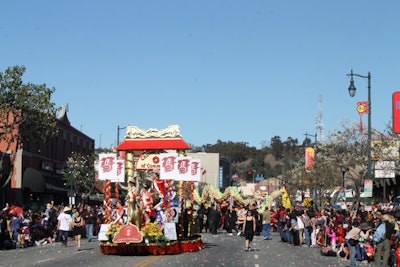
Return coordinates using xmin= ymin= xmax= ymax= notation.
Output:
xmin=63 ymin=152 xmax=96 ymax=195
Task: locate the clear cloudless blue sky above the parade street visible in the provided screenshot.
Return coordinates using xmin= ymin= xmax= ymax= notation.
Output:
xmin=0 ymin=0 xmax=400 ymax=148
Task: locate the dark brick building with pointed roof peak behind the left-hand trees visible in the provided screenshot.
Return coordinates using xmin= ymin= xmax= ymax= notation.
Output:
xmin=0 ymin=107 xmax=95 ymax=207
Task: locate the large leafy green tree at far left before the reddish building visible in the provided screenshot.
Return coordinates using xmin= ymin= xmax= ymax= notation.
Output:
xmin=0 ymin=66 xmax=57 ymax=187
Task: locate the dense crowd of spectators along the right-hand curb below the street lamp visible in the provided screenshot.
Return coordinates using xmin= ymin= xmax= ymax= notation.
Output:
xmin=276 ymin=201 xmax=400 ymax=266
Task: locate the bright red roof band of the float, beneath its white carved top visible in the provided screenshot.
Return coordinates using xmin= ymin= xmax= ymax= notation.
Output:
xmin=117 ymin=138 xmax=190 ymax=151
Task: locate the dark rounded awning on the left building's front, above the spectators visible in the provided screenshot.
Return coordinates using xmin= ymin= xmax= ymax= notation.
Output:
xmin=22 ymin=168 xmax=69 ymax=193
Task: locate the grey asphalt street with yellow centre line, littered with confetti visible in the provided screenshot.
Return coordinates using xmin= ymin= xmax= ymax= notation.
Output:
xmin=0 ymin=232 xmax=354 ymax=267
